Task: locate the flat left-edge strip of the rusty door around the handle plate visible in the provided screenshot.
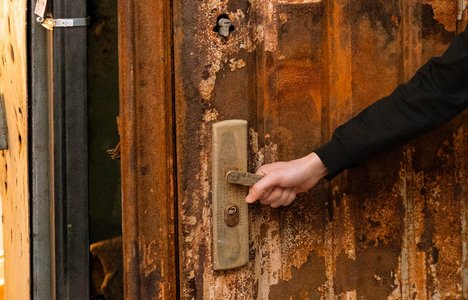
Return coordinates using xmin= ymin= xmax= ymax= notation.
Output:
xmin=174 ymin=0 xmax=256 ymax=299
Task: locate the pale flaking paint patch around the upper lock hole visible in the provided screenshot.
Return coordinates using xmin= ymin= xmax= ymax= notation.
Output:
xmin=191 ymin=0 xmax=330 ymax=102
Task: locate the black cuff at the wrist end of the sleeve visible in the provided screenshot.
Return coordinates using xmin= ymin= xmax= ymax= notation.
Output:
xmin=315 ymin=139 xmax=354 ymax=180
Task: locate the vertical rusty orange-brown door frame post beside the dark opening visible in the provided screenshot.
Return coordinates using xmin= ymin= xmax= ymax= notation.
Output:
xmin=119 ymin=0 xmax=177 ymax=299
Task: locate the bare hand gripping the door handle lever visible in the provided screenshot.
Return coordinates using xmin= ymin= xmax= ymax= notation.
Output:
xmin=245 ymin=153 xmax=327 ymax=208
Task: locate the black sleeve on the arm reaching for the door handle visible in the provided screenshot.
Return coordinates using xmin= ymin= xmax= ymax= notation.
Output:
xmin=315 ymin=30 xmax=468 ymax=179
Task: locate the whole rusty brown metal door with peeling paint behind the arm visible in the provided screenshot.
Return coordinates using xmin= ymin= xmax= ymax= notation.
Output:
xmin=174 ymin=0 xmax=468 ymax=299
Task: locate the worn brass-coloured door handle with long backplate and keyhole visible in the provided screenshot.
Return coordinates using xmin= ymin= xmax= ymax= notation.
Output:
xmin=211 ymin=120 xmax=252 ymax=270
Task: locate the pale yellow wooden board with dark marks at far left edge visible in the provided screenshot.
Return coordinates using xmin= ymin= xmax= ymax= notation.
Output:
xmin=0 ymin=0 xmax=30 ymax=299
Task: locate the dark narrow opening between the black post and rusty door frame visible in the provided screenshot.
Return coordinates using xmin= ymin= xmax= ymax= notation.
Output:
xmin=87 ymin=0 xmax=123 ymax=300
